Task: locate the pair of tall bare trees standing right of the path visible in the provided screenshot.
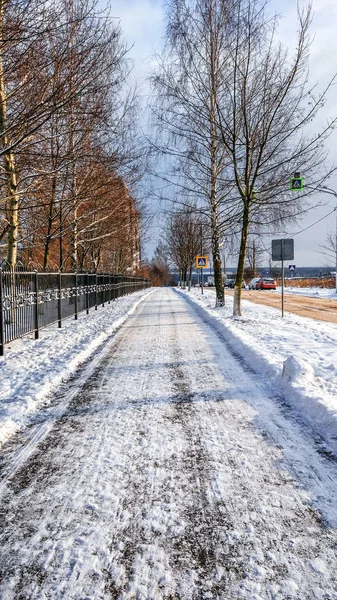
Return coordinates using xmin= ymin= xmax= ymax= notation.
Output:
xmin=152 ymin=0 xmax=336 ymax=315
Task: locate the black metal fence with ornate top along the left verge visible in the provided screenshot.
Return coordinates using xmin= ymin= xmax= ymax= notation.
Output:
xmin=0 ymin=269 xmax=151 ymax=356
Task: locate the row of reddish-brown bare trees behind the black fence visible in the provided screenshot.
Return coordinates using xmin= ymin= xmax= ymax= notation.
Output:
xmin=0 ymin=0 xmax=141 ymax=272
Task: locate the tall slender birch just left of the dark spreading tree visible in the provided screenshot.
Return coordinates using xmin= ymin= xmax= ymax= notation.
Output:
xmin=153 ymin=0 xmax=239 ymax=305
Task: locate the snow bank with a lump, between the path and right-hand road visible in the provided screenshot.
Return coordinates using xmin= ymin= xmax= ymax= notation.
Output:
xmin=180 ymin=289 xmax=337 ymax=454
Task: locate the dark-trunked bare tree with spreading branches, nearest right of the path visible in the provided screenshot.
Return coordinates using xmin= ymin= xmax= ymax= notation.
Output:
xmin=217 ymin=0 xmax=336 ymax=315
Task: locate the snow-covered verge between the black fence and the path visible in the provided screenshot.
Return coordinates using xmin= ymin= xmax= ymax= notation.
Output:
xmin=0 ymin=290 xmax=151 ymax=445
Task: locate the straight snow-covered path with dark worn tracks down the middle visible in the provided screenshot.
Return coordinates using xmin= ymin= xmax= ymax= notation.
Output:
xmin=0 ymin=289 xmax=337 ymax=600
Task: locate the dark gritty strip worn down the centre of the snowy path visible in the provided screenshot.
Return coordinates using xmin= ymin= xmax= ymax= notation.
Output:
xmin=160 ymin=298 xmax=243 ymax=599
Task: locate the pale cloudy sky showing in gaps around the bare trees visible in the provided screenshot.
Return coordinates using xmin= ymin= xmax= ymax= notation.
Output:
xmin=105 ymin=0 xmax=337 ymax=267
